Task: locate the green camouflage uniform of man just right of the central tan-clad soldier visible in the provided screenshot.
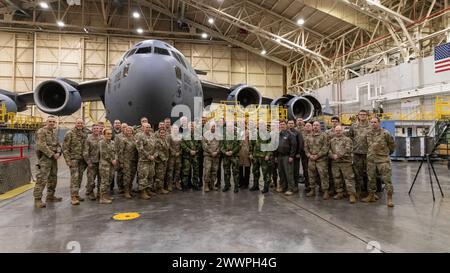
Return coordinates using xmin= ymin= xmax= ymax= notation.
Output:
xmin=220 ymin=132 xmax=241 ymax=191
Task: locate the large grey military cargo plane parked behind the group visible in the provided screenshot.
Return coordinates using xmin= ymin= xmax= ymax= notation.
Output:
xmin=0 ymin=40 xmax=322 ymax=124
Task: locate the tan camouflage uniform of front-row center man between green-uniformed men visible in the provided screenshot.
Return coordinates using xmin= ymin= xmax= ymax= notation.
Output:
xmin=202 ymin=133 xmax=220 ymax=191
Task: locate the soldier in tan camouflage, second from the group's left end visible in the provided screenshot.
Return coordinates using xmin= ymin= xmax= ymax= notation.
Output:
xmin=63 ymin=119 xmax=87 ymax=205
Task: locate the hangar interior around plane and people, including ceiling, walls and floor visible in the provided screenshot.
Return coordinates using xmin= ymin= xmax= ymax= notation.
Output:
xmin=0 ymin=0 xmax=450 ymax=252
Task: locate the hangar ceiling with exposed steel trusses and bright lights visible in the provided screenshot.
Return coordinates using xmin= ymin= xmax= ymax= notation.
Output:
xmin=0 ymin=0 xmax=450 ymax=92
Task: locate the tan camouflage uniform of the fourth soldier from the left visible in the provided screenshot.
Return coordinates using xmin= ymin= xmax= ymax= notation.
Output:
xmin=98 ymin=139 xmax=117 ymax=195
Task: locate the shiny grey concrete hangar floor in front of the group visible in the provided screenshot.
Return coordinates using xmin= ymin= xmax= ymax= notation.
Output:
xmin=0 ymin=156 xmax=450 ymax=252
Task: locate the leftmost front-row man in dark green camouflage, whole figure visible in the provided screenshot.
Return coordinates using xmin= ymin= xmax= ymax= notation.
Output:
xmin=167 ymin=125 xmax=182 ymax=192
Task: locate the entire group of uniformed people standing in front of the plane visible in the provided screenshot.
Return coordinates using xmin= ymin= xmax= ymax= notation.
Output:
xmin=34 ymin=110 xmax=394 ymax=208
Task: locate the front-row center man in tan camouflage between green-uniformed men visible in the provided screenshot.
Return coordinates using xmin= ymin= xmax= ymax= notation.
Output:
xmin=202 ymin=122 xmax=220 ymax=192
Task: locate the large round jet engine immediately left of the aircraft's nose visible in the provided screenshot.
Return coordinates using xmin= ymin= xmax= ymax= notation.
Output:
xmin=33 ymin=79 xmax=81 ymax=116
